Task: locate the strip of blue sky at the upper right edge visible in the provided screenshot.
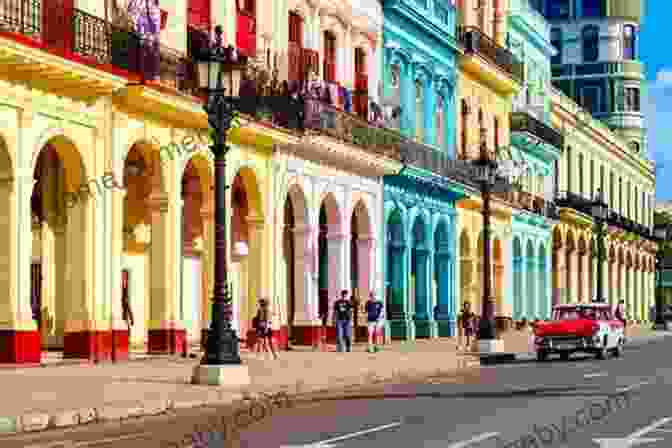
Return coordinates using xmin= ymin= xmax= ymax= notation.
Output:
xmin=640 ymin=0 xmax=672 ymax=200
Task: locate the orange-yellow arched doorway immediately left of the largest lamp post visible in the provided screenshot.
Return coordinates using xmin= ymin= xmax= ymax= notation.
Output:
xmin=180 ymin=156 xmax=214 ymax=343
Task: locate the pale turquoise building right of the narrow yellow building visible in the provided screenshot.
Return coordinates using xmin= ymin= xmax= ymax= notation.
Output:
xmin=507 ymin=0 xmax=563 ymax=320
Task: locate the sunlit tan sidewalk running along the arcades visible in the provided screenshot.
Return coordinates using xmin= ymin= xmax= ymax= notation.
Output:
xmin=0 ymin=339 xmax=478 ymax=434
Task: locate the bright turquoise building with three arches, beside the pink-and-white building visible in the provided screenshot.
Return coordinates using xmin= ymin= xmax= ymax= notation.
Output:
xmin=382 ymin=0 xmax=465 ymax=339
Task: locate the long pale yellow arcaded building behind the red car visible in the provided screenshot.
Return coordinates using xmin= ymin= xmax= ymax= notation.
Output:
xmin=552 ymin=90 xmax=657 ymax=321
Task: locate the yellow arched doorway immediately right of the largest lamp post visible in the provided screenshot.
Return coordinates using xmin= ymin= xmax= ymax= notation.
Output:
xmin=230 ymin=167 xmax=264 ymax=346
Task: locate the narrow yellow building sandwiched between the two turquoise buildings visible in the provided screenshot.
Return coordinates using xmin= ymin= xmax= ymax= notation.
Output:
xmin=457 ymin=0 xmax=523 ymax=325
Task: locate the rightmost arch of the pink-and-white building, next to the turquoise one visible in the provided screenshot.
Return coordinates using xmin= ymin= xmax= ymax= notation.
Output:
xmin=350 ymin=200 xmax=373 ymax=339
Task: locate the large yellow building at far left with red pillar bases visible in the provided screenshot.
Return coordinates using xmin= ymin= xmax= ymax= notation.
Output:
xmin=0 ymin=0 xmax=294 ymax=362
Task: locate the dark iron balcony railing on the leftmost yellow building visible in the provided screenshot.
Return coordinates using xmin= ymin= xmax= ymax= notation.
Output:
xmin=0 ymin=0 xmax=195 ymax=93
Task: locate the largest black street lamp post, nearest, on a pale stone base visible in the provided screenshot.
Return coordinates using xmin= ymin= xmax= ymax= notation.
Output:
xmin=193 ymin=26 xmax=250 ymax=385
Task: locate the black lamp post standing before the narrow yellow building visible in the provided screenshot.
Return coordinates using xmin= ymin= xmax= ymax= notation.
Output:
xmin=474 ymin=128 xmax=498 ymax=341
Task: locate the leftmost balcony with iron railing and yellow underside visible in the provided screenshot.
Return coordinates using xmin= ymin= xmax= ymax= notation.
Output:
xmin=0 ymin=0 xmax=201 ymax=125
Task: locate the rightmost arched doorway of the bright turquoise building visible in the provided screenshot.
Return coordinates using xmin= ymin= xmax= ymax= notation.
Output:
xmin=434 ymin=219 xmax=455 ymax=337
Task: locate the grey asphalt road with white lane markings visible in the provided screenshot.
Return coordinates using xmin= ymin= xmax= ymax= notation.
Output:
xmin=0 ymin=338 xmax=672 ymax=448
